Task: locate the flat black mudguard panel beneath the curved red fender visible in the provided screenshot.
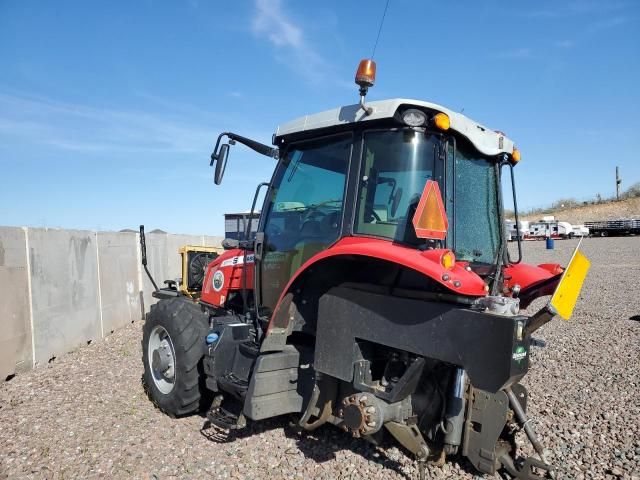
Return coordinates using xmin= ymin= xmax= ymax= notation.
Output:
xmin=315 ymin=287 xmax=529 ymax=393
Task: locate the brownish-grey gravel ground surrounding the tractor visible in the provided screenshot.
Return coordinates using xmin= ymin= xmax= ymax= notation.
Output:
xmin=0 ymin=237 xmax=640 ymax=480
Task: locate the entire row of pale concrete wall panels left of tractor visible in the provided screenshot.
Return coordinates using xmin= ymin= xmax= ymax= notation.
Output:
xmin=0 ymin=227 xmax=222 ymax=380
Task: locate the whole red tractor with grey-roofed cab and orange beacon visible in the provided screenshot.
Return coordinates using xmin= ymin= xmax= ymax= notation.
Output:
xmin=142 ymin=61 xmax=588 ymax=479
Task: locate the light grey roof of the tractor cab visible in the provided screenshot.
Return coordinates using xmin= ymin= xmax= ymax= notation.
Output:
xmin=276 ymin=98 xmax=514 ymax=156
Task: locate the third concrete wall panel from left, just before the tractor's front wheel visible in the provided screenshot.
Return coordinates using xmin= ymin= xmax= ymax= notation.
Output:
xmin=97 ymin=232 xmax=143 ymax=337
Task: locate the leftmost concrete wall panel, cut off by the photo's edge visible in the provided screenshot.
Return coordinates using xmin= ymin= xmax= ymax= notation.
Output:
xmin=0 ymin=227 xmax=33 ymax=381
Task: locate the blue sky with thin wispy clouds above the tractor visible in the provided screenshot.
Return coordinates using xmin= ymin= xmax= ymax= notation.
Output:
xmin=0 ymin=0 xmax=640 ymax=234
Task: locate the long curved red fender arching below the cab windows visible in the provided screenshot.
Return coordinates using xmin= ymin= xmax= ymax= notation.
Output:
xmin=268 ymin=237 xmax=487 ymax=330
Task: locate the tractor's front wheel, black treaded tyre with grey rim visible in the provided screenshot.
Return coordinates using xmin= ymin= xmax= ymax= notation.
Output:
xmin=142 ymin=297 xmax=211 ymax=417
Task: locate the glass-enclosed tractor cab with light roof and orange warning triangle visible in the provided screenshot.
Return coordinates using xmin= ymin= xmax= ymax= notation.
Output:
xmin=208 ymin=88 xmax=524 ymax=319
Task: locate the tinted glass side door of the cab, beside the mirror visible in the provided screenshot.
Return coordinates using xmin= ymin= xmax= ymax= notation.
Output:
xmin=256 ymin=134 xmax=353 ymax=316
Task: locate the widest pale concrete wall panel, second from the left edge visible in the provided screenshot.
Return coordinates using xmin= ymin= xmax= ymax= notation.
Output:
xmin=28 ymin=228 xmax=102 ymax=366
